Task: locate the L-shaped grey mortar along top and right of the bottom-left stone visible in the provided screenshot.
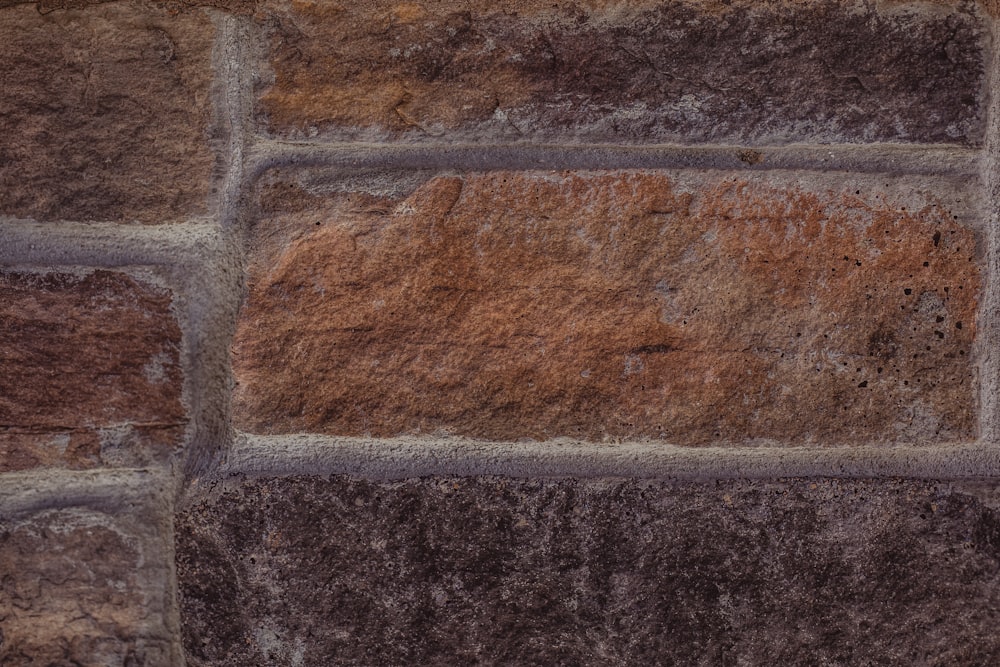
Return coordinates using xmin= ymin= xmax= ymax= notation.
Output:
xmin=0 ymin=469 xmax=184 ymax=667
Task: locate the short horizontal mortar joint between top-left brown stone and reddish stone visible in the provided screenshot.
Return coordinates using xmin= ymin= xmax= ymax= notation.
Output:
xmin=0 ymin=217 xmax=223 ymax=268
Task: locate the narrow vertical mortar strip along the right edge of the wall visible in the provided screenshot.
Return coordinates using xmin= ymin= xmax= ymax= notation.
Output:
xmin=976 ymin=10 xmax=1000 ymax=445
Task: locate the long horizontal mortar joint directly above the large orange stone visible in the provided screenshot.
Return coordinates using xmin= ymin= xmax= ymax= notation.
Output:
xmin=247 ymin=139 xmax=982 ymax=179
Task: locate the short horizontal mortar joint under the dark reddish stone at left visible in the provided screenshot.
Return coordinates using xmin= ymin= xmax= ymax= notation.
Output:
xmin=0 ymin=468 xmax=174 ymax=518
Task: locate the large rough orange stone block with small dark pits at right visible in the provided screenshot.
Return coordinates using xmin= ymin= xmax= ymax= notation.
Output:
xmin=234 ymin=172 xmax=980 ymax=444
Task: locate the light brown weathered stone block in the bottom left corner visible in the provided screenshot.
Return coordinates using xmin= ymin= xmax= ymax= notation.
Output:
xmin=0 ymin=488 xmax=178 ymax=667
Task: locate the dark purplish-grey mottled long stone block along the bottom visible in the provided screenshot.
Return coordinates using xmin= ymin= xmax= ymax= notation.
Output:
xmin=177 ymin=477 xmax=1000 ymax=666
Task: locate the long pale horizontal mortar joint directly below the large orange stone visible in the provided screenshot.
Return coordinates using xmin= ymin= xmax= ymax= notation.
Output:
xmin=223 ymin=434 xmax=1000 ymax=480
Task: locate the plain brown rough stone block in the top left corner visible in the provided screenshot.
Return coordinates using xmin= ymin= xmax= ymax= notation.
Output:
xmin=0 ymin=2 xmax=215 ymax=222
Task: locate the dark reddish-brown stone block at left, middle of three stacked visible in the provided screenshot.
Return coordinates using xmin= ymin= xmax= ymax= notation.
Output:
xmin=0 ymin=271 xmax=186 ymax=471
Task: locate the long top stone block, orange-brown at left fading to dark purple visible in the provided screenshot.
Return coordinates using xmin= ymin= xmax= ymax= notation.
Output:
xmin=259 ymin=0 xmax=985 ymax=144
